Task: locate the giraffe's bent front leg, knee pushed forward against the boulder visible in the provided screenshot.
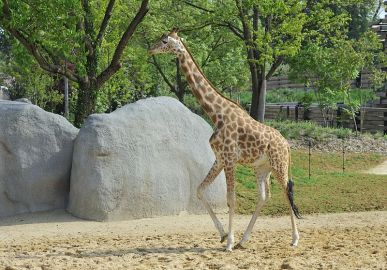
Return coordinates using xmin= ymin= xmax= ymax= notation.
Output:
xmin=197 ymin=160 xmax=227 ymax=239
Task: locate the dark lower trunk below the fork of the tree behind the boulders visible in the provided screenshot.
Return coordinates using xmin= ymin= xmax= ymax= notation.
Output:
xmin=74 ymin=80 xmax=97 ymax=127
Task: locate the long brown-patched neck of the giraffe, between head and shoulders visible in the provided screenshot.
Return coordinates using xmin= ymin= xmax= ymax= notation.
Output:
xmin=177 ymin=46 xmax=231 ymax=122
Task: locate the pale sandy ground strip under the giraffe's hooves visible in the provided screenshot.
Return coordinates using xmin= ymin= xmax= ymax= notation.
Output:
xmin=0 ymin=211 xmax=387 ymax=270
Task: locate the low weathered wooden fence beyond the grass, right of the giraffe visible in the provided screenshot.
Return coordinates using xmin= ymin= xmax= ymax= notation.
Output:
xmin=265 ymin=103 xmax=387 ymax=134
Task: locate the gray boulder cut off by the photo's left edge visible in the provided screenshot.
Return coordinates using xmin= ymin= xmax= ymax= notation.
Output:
xmin=0 ymin=100 xmax=78 ymax=217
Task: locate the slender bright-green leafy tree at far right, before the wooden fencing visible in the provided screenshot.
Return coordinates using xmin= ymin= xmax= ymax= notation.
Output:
xmin=289 ymin=1 xmax=386 ymax=129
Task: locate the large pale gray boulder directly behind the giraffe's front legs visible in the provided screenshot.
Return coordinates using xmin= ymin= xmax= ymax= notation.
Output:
xmin=68 ymin=97 xmax=226 ymax=221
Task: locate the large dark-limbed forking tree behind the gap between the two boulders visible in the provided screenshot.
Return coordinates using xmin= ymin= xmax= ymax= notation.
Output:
xmin=0 ymin=0 xmax=149 ymax=126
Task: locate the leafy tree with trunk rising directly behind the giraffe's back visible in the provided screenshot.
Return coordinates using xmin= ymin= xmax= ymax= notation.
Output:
xmin=184 ymin=0 xmax=368 ymax=121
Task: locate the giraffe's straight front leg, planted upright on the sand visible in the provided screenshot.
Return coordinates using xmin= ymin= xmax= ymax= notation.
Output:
xmin=224 ymin=167 xmax=236 ymax=252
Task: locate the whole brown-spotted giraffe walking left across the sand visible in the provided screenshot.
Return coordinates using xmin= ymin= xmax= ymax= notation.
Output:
xmin=149 ymin=28 xmax=300 ymax=251
